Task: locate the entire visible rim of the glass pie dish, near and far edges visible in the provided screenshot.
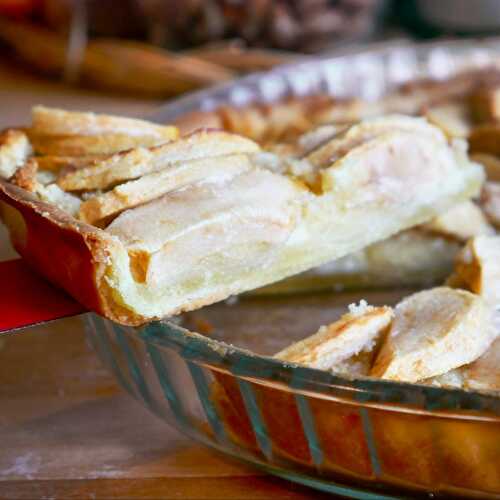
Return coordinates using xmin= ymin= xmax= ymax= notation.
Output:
xmin=137 ymin=37 xmax=500 ymax=414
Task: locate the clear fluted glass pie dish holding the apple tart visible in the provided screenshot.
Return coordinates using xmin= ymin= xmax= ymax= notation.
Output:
xmin=87 ymin=40 xmax=500 ymax=498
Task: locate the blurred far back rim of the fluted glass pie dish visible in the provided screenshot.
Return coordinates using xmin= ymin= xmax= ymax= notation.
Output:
xmin=147 ymin=36 xmax=500 ymax=123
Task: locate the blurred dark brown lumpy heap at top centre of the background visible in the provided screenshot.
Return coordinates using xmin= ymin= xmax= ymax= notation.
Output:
xmin=137 ymin=0 xmax=383 ymax=52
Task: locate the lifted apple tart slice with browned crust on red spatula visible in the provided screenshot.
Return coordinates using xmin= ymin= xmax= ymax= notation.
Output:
xmin=0 ymin=110 xmax=483 ymax=324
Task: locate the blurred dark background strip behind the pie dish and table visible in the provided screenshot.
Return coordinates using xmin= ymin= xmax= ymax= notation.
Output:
xmin=0 ymin=0 xmax=500 ymax=100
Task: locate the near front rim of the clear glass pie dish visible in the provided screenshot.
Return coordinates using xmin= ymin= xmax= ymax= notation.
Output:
xmin=122 ymin=313 xmax=500 ymax=423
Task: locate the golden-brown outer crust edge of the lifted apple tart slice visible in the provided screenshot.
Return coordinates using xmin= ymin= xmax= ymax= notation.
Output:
xmin=0 ymin=180 xmax=145 ymax=324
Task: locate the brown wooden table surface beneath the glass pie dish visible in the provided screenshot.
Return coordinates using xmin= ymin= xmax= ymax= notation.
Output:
xmin=0 ymin=64 xmax=338 ymax=500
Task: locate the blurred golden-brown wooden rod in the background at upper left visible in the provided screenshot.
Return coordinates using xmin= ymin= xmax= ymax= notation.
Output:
xmin=0 ymin=18 xmax=234 ymax=97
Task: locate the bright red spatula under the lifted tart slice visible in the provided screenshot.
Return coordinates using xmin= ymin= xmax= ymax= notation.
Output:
xmin=0 ymin=259 xmax=85 ymax=333
